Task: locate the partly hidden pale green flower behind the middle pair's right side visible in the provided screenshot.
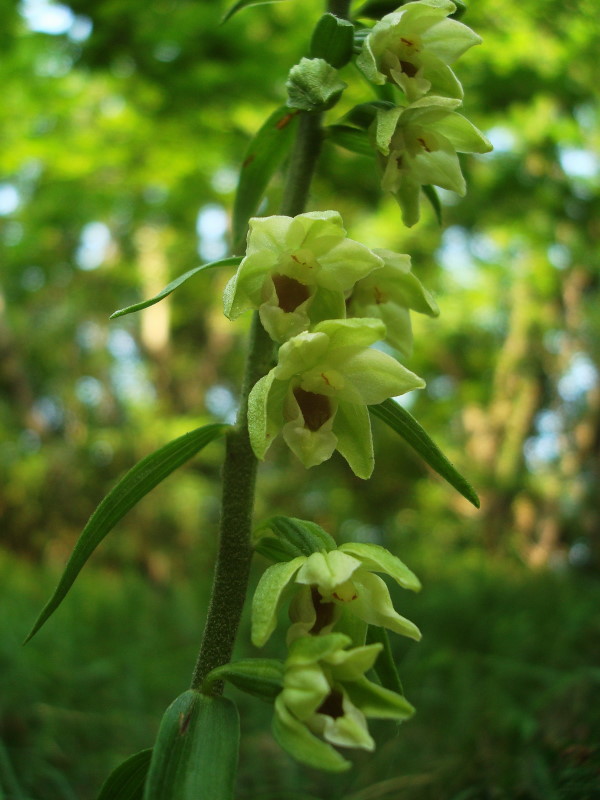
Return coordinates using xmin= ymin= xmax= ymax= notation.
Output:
xmin=346 ymin=245 xmax=440 ymax=356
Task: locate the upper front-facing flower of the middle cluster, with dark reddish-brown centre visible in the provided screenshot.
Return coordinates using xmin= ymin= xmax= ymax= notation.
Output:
xmin=224 ymin=211 xmax=383 ymax=342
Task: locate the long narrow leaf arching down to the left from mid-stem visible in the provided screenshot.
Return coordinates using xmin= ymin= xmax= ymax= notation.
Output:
xmin=25 ymin=423 xmax=229 ymax=642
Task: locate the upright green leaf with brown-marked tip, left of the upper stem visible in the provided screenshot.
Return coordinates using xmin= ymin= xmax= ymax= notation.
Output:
xmin=232 ymin=106 xmax=298 ymax=246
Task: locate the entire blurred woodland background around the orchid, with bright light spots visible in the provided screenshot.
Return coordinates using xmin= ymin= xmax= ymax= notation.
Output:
xmin=0 ymin=0 xmax=600 ymax=800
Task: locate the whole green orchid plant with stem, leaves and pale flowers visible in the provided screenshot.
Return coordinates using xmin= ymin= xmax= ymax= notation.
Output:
xmin=25 ymin=0 xmax=490 ymax=800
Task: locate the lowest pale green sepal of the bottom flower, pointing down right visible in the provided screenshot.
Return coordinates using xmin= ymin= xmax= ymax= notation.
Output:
xmin=272 ymin=697 xmax=352 ymax=772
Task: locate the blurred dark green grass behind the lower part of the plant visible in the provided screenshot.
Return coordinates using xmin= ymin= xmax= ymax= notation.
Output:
xmin=0 ymin=554 xmax=600 ymax=800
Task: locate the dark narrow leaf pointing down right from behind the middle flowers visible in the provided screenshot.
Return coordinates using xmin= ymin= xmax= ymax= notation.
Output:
xmin=369 ymin=399 xmax=480 ymax=508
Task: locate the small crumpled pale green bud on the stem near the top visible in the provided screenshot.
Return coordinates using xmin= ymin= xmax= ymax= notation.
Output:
xmin=285 ymin=58 xmax=348 ymax=111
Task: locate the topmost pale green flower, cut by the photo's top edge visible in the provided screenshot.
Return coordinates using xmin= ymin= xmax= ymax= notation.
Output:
xmin=356 ymin=0 xmax=481 ymax=102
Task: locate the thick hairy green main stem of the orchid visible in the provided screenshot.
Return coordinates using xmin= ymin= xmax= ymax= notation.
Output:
xmin=192 ymin=103 xmax=321 ymax=694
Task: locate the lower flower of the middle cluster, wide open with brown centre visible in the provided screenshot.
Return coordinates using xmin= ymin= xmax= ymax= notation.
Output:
xmin=248 ymin=319 xmax=425 ymax=478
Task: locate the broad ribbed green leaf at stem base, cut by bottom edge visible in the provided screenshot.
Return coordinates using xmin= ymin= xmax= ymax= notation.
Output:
xmin=144 ymin=689 xmax=240 ymax=800
